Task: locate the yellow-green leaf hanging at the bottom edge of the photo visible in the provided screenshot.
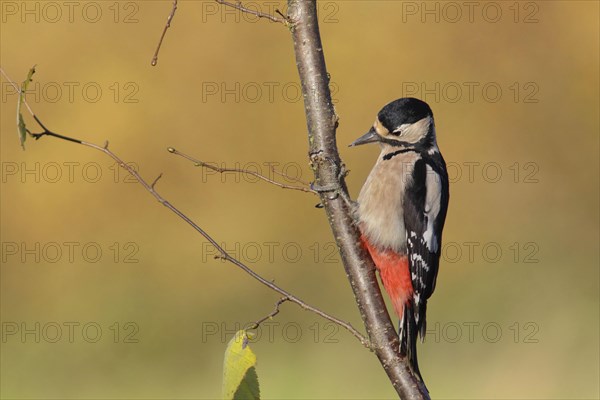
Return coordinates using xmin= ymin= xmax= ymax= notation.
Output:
xmin=223 ymin=330 xmax=260 ymax=400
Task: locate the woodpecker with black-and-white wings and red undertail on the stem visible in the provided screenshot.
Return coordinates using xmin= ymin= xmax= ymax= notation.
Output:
xmin=350 ymin=97 xmax=450 ymax=382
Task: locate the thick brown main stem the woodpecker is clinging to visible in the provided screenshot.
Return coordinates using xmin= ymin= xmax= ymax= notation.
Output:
xmin=288 ymin=0 xmax=429 ymax=399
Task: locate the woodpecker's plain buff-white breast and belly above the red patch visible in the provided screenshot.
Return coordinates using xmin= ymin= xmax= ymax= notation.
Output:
xmin=358 ymin=150 xmax=420 ymax=253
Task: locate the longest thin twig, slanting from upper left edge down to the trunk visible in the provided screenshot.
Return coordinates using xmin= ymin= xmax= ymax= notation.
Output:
xmin=0 ymin=67 xmax=371 ymax=349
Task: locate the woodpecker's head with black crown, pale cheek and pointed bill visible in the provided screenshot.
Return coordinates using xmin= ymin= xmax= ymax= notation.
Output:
xmin=350 ymin=97 xmax=435 ymax=150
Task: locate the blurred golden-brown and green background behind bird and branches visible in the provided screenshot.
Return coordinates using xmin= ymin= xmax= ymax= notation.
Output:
xmin=0 ymin=1 xmax=600 ymax=399
